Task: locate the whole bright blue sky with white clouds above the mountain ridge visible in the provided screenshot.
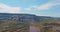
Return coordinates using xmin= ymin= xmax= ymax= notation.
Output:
xmin=0 ymin=0 xmax=60 ymax=17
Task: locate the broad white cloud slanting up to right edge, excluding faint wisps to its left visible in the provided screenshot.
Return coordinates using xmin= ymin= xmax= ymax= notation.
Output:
xmin=36 ymin=0 xmax=60 ymax=10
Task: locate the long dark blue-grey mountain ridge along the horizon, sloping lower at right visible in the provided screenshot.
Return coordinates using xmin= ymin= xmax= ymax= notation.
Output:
xmin=0 ymin=13 xmax=60 ymax=22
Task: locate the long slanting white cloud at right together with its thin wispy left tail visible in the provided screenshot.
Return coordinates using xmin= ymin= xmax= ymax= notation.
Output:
xmin=26 ymin=0 xmax=60 ymax=11
